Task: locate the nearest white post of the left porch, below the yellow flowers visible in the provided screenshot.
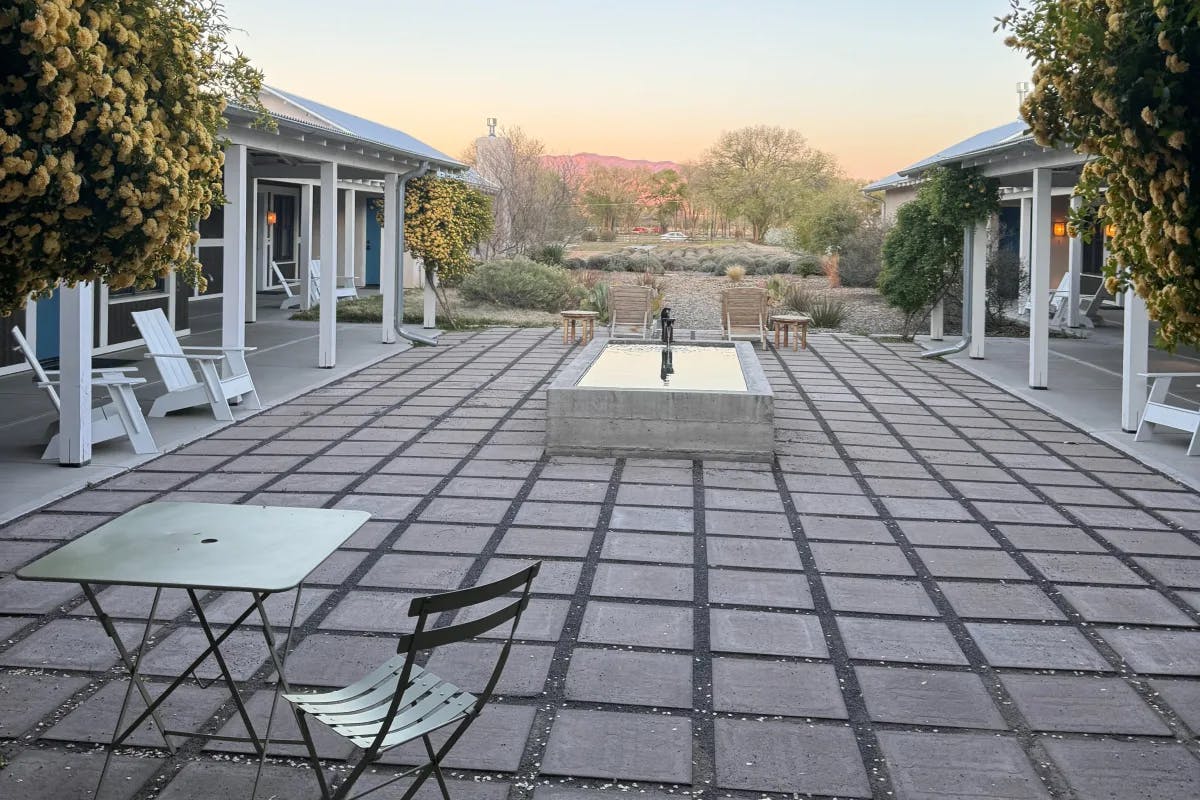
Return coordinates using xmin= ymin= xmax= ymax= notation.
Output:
xmin=59 ymin=283 xmax=95 ymax=467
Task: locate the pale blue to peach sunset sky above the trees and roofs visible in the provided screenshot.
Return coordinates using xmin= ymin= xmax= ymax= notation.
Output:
xmin=224 ymin=0 xmax=1030 ymax=180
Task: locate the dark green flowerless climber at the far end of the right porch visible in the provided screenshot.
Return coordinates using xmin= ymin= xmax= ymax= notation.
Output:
xmin=878 ymin=168 xmax=1000 ymax=337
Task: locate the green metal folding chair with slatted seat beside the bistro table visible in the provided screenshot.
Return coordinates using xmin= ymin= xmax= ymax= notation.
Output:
xmin=283 ymin=561 xmax=541 ymax=800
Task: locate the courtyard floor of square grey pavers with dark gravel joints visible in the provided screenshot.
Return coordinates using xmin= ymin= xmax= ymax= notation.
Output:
xmin=0 ymin=329 xmax=1200 ymax=800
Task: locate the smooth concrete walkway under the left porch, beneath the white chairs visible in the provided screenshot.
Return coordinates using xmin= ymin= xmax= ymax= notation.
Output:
xmin=0 ymin=293 xmax=422 ymax=522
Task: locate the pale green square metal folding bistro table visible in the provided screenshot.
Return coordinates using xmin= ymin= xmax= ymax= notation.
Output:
xmin=17 ymin=503 xmax=371 ymax=798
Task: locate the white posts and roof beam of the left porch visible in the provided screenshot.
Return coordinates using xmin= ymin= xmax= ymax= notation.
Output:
xmin=59 ymin=106 xmax=464 ymax=467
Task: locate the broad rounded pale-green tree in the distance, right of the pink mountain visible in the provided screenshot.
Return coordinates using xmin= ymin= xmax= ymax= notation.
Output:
xmin=702 ymin=125 xmax=836 ymax=241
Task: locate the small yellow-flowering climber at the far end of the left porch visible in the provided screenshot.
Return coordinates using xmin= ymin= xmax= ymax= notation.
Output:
xmin=405 ymin=175 xmax=493 ymax=323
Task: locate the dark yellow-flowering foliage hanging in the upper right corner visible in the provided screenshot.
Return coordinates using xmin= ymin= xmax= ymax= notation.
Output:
xmin=998 ymin=0 xmax=1200 ymax=347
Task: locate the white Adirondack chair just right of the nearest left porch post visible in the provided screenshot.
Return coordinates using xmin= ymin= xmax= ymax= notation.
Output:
xmin=133 ymin=308 xmax=263 ymax=422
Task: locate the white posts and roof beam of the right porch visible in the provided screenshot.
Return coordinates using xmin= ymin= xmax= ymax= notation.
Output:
xmin=899 ymin=136 xmax=1150 ymax=433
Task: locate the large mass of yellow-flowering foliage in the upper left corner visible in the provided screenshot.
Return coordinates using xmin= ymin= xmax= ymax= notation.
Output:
xmin=0 ymin=0 xmax=262 ymax=314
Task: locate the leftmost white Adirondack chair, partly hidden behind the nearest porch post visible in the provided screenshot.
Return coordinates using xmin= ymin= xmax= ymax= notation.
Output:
xmin=12 ymin=327 xmax=158 ymax=459
